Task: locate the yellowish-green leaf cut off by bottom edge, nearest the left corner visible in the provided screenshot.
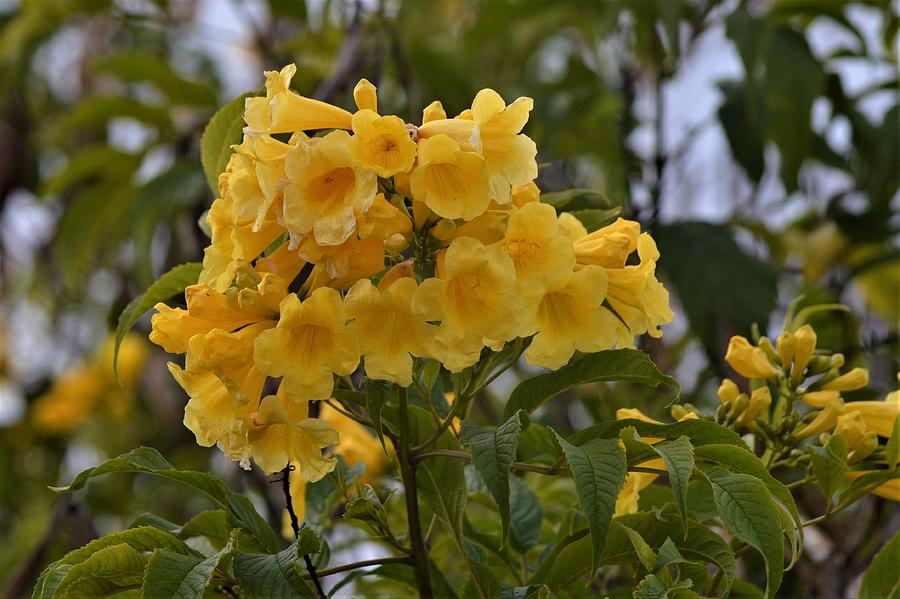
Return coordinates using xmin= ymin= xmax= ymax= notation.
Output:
xmin=54 ymin=543 xmax=144 ymax=599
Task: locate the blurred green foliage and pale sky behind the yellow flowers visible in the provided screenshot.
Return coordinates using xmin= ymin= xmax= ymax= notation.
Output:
xmin=0 ymin=0 xmax=900 ymax=597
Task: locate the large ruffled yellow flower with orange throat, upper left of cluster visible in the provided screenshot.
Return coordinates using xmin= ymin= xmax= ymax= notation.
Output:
xmin=284 ymin=131 xmax=378 ymax=245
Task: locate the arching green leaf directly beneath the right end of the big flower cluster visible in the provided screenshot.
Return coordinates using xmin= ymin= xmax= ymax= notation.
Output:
xmin=503 ymin=349 xmax=681 ymax=419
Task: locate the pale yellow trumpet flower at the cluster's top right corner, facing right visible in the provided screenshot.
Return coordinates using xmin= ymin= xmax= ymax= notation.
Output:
xmin=472 ymin=89 xmax=537 ymax=203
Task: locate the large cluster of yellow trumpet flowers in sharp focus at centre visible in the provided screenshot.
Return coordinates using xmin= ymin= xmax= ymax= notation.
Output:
xmin=151 ymin=65 xmax=672 ymax=480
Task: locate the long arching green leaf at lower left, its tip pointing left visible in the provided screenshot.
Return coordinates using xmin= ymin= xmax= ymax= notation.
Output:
xmin=54 ymin=447 xmax=278 ymax=551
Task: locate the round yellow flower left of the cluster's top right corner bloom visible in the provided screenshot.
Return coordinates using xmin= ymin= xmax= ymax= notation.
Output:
xmin=410 ymin=135 xmax=491 ymax=220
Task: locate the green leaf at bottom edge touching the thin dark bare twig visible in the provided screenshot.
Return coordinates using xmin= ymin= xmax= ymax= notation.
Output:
xmin=233 ymin=541 xmax=316 ymax=599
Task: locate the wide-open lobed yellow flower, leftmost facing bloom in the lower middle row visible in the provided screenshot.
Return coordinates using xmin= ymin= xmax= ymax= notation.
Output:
xmin=253 ymin=287 xmax=359 ymax=400
